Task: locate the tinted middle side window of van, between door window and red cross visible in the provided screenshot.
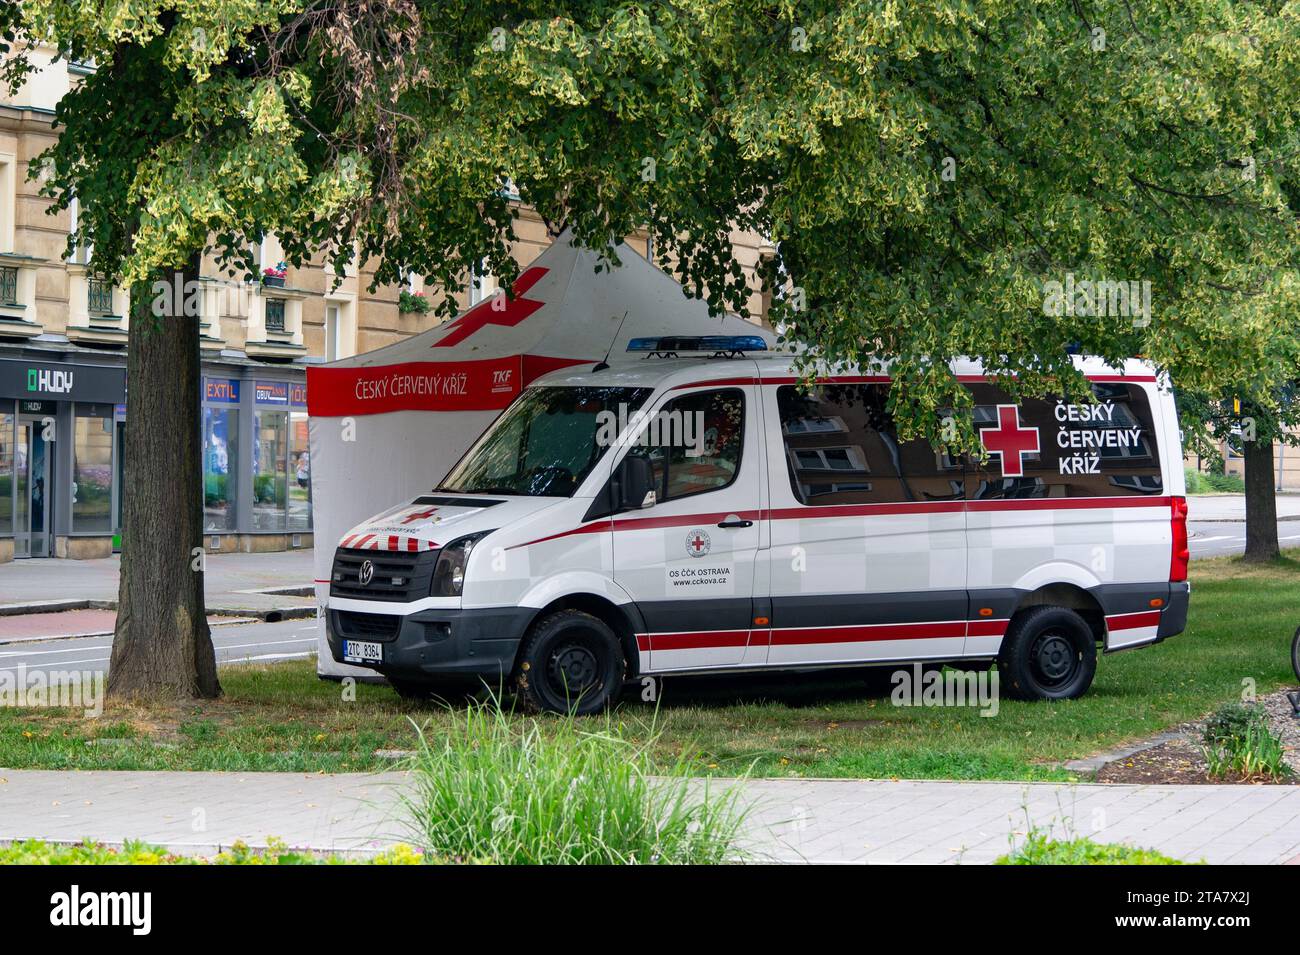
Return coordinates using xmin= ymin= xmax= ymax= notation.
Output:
xmin=776 ymin=385 xmax=965 ymax=504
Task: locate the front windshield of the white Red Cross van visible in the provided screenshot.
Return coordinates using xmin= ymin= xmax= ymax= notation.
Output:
xmin=437 ymin=387 xmax=653 ymax=498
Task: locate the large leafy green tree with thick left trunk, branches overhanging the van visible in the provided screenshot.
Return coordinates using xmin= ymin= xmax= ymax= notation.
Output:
xmin=16 ymin=0 xmax=1300 ymax=694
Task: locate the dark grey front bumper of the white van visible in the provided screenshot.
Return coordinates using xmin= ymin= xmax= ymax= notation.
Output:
xmin=325 ymin=607 xmax=537 ymax=682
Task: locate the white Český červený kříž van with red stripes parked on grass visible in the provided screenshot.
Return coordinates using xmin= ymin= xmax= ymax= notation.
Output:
xmin=326 ymin=338 xmax=1188 ymax=712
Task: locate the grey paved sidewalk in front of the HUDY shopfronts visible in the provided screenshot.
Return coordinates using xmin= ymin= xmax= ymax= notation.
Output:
xmin=0 ymin=548 xmax=315 ymax=613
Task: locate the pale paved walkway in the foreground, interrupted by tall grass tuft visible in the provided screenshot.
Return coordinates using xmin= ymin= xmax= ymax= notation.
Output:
xmin=0 ymin=769 xmax=1300 ymax=864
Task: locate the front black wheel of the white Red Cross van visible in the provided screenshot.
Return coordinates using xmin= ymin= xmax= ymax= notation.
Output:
xmin=515 ymin=611 xmax=625 ymax=716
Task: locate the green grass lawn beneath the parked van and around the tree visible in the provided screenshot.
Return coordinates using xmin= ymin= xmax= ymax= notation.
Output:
xmin=0 ymin=557 xmax=1300 ymax=780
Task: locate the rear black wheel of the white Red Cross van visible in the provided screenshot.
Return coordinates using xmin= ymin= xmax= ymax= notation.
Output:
xmin=997 ymin=607 xmax=1097 ymax=700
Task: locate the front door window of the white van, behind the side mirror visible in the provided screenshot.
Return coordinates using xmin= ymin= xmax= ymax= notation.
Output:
xmin=633 ymin=388 xmax=745 ymax=502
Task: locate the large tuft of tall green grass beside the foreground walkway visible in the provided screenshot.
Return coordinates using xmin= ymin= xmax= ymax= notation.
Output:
xmin=402 ymin=702 xmax=744 ymax=865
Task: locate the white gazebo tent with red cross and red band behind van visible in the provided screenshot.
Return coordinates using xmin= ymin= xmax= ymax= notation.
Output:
xmin=307 ymin=234 xmax=774 ymax=677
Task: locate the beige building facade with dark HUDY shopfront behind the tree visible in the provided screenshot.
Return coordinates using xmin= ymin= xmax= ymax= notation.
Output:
xmin=0 ymin=52 xmax=771 ymax=561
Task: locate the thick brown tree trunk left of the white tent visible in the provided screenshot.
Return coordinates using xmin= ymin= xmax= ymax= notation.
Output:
xmin=108 ymin=255 xmax=221 ymax=698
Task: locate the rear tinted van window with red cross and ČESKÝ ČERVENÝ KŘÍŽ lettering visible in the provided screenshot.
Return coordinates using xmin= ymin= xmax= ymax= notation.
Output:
xmin=967 ymin=382 xmax=1164 ymax=500
